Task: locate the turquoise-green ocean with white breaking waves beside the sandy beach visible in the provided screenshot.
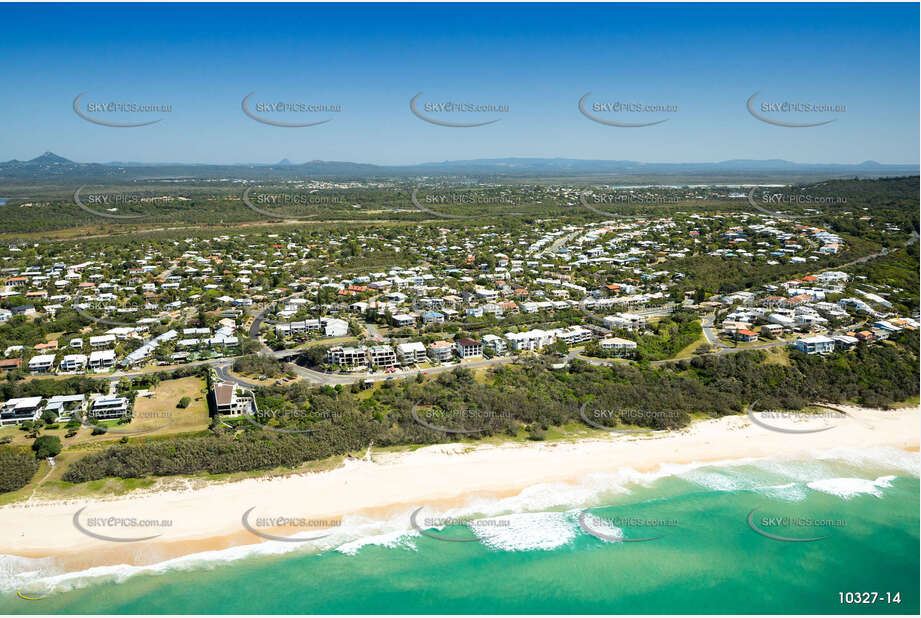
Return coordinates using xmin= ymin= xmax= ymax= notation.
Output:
xmin=0 ymin=448 xmax=919 ymax=614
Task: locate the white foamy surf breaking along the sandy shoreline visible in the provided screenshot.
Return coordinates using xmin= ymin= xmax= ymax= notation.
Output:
xmin=0 ymin=448 xmax=921 ymax=592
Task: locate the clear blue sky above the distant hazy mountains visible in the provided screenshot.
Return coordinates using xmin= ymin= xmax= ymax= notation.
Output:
xmin=0 ymin=4 xmax=919 ymax=164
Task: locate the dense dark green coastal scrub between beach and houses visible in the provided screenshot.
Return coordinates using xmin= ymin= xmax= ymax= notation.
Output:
xmin=57 ymin=333 xmax=919 ymax=483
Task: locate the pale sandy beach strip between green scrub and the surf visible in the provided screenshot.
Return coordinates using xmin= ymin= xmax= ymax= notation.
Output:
xmin=0 ymin=406 xmax=921 ymax=570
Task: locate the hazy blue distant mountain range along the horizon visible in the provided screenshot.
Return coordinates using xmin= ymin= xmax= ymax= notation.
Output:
xmin=0 ymin=152 xmax=919 ymax=182
